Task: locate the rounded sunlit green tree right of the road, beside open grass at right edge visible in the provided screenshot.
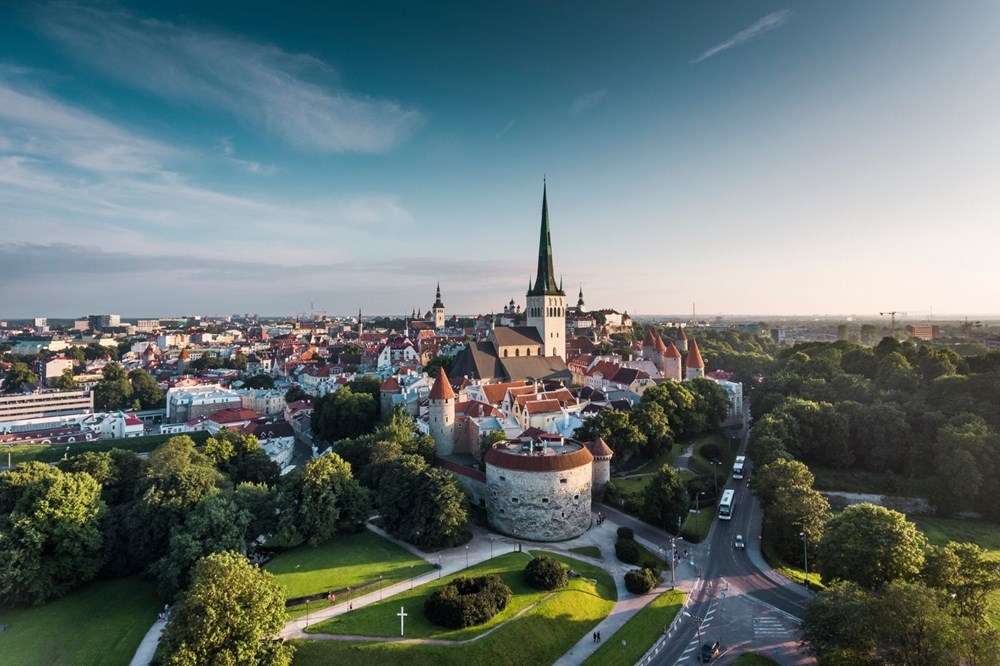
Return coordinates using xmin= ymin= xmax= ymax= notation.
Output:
xmin=816 ymin=504 xmax=926 ymax=590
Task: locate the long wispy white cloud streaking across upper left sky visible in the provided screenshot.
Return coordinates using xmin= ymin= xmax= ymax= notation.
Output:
xmin=39 ymin=3 xmax=425 ymax=153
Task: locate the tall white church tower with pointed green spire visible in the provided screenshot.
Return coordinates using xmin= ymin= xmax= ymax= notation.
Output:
xmin=526 ymin=179 xmax=566 ymax=360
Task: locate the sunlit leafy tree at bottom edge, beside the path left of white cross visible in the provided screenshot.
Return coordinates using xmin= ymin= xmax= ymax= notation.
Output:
xmin=161 ymin=552 xmax=293 ymax=666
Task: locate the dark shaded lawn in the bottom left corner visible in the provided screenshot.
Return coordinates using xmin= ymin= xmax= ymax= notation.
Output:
xmin=0 ymin=577 xmax=163 ymax=666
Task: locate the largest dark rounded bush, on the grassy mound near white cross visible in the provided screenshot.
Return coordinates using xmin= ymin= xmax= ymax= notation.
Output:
xmin=424 ymin=575 xmax=513 ymax=629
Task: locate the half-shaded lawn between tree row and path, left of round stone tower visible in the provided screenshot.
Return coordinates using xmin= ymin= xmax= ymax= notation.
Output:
xmin=264 ymin=530 xmax=434 ymax=603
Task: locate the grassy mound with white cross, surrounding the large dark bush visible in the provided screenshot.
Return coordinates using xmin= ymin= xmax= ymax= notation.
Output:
xmin=295 ymin=553 xmax=617 ymax=666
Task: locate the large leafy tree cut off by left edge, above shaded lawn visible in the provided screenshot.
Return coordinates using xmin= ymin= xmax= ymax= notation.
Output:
xmin=0 ymin=462 xmax=105 ymax=604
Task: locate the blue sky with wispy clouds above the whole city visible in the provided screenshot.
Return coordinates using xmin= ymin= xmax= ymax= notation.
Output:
xmin=0 ymin=0 xmax=1000 ymax=318
